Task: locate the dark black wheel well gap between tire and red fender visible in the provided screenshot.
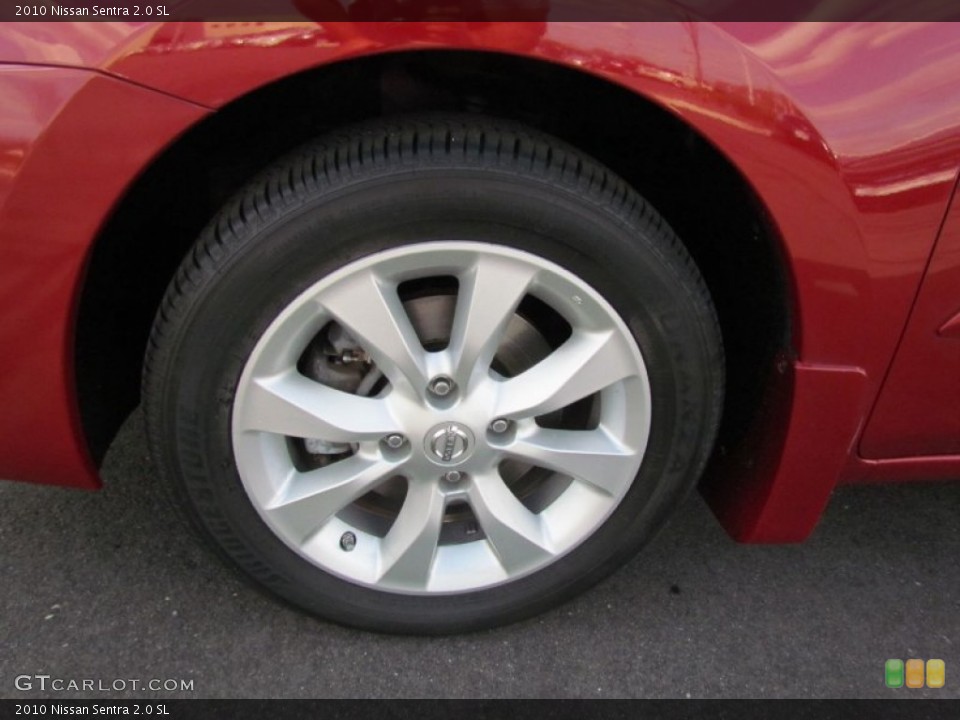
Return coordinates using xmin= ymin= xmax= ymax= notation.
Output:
xmin=75 ymin=50 xmax=791 ymax=463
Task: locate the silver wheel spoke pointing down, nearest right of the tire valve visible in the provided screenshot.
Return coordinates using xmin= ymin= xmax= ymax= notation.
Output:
xmin=379 ymin=482 xmax=446 ymax=590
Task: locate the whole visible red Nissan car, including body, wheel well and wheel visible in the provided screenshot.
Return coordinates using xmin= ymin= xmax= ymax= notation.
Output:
xmin=0 ymin=19 xmax=960 ymax=633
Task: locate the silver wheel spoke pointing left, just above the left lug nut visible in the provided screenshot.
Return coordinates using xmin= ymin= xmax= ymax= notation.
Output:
xmin=235 ymin=370 xmax=397 ymax=442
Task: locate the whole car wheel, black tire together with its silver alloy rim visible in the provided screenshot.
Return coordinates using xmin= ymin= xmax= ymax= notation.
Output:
xmin=143 ymin=116 xmax=723 ymax=634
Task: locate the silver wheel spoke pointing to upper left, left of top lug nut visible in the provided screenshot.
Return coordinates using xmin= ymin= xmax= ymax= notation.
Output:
xmin=320 ymin=272 xmax=427 ymax=392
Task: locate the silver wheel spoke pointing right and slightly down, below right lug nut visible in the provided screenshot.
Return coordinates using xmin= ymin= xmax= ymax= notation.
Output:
xmin=507 ymin=427 xmax=636 ymax=495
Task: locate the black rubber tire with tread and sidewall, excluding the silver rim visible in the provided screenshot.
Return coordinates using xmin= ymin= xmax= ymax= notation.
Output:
xmin=143 ymin=116 xmax=724 ymax=634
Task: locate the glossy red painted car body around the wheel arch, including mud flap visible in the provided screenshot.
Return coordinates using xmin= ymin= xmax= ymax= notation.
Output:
xmin=0 ymin=22 xmax=960 ymax=542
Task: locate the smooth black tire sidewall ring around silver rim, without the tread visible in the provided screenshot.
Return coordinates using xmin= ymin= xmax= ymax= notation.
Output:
xmin=152 ymin=156 xmax=719 ymax=632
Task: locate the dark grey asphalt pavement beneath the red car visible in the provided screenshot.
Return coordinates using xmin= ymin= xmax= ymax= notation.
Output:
xmin=0 ymin=413 xmax=960 ymax=700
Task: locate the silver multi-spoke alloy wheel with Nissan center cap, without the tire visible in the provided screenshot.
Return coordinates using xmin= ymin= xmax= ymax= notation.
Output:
xmin=232 ymin=241 xmax=651 ymax=594
